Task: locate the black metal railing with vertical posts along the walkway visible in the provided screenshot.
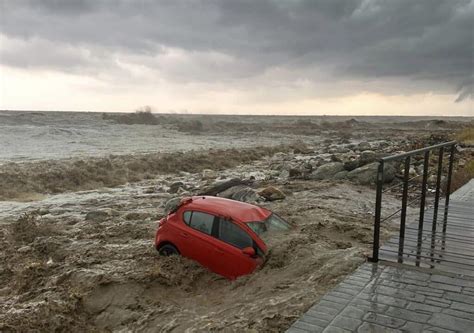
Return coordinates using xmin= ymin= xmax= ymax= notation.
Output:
xmin=369 ymin=141 xmax=456 ymax=262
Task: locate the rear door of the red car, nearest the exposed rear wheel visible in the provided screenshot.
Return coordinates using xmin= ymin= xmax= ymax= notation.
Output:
xmin=180 ymin=210 xmax=216 ymax=270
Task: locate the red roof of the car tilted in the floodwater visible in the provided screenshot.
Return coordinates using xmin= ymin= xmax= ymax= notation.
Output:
xmin=183 ymin=196 xmax=271 ymax=223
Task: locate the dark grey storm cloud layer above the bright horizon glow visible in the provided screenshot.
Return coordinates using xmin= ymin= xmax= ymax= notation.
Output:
xmin=0 ymin=0 xmax=474 ymax=101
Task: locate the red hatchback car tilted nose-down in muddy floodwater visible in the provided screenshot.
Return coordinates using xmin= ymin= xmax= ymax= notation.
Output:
xmin=155 ymin=196 xmax=290 ymax=279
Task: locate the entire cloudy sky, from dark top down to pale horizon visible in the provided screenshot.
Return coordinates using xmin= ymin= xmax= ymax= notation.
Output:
xmin=0 ymin=0 xmax=474 ymax=116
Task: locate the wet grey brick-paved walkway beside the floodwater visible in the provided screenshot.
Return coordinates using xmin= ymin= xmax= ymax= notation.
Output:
xmin=287 ymin=180 xmax=474 ymax=333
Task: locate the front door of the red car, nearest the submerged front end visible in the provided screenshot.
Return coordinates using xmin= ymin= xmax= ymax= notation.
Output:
xmin=213 ymin=218 xmax=262 ymax=278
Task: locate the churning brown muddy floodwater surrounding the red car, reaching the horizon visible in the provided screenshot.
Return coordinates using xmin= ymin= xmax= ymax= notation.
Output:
xmin=0 ymin=112 xmax=472 ymax=332
